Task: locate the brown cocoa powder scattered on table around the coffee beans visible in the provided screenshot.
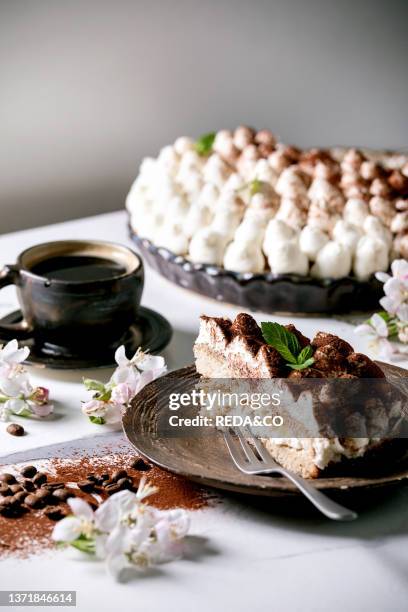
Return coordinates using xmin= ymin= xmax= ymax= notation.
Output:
xmin=0 ymin=449 xmax=211 ymax=558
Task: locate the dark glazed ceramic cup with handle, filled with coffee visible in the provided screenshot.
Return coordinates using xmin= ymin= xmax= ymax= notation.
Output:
xmin=0 ymin=240 xmax=144 ymax=354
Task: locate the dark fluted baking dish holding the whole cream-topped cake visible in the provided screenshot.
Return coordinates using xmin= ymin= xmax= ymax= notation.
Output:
xmin=130 ymin=228 xmax=383 ymax=314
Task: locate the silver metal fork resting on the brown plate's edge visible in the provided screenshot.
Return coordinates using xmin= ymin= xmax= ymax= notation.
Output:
xmin=223 ymin=427 xmax=358 ymax=521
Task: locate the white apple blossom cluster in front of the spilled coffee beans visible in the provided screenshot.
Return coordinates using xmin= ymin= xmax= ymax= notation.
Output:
xmin=52 ymin=478 xmax=190 ymax=580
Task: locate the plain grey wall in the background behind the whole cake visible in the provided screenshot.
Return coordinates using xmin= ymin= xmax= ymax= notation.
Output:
xmin=0 ymin=0 xmax=408 ymax=232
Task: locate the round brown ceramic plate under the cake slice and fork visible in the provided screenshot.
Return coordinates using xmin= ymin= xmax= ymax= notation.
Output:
xmin=123 ymin=363 xmax=408 ymax=498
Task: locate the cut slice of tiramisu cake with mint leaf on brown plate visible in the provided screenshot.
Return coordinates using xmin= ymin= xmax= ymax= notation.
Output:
xmin=194 ymin=313 xmax=402 ymax=478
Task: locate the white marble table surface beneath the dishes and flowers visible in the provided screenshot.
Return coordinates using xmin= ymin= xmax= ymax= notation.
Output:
xmin=0 ymin=212 xmax=408 ymax=612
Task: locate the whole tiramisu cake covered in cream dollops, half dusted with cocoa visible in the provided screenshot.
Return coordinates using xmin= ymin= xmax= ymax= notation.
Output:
xmin=126 ymin=126 xmax=408 ymax=280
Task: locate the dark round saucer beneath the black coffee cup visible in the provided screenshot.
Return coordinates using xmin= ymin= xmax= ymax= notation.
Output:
xmin=0 ymin=306 xmax=173 ymax=370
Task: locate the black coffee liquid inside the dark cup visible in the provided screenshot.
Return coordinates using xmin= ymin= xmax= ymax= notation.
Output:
xmin=31 ymin=255 xmax=126 ymax=281
